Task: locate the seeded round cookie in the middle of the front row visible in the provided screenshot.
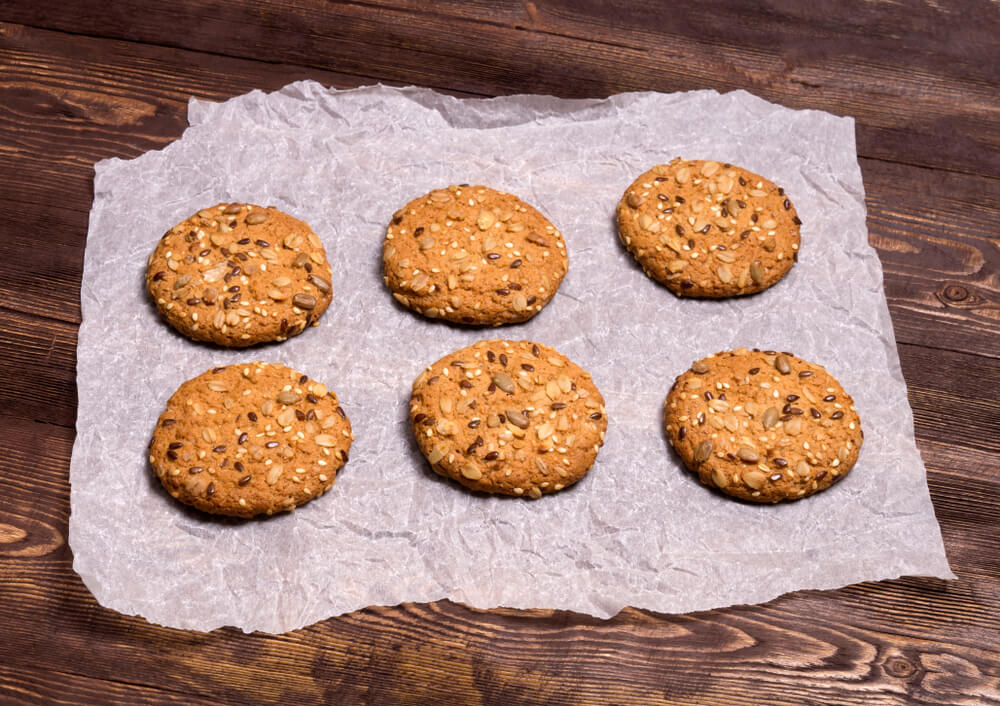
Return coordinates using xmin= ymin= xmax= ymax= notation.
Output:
xmin=410 ymin=340 xmax=608 ymax=498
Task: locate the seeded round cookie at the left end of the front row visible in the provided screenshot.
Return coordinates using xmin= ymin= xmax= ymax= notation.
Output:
xmin=149 ymin=363 xmax=354 ymax=517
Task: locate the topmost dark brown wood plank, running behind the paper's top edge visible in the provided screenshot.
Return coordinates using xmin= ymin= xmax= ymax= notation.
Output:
xmin=3 ymin=0 xmax=1000 ymax=177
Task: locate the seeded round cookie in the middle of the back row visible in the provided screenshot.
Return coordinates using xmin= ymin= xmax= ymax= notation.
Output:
xmin=382 ymin=184 xmax=569 ymax=326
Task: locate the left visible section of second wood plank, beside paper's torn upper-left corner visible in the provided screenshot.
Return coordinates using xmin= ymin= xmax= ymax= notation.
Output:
xmin=0 ymin=24 xmax=364 ymax=323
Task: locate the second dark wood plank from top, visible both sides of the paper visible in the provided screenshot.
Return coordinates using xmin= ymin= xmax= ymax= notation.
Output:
xmin=0 ymin=25 xmax=1000 ymax=356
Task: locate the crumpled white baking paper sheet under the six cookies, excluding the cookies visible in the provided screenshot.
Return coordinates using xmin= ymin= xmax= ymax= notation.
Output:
xmin=70 ymin=82 xmax=954 ymax=633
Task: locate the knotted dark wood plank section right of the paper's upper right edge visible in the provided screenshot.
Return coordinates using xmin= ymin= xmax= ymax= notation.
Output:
xmin=861 ymin=159 xmax=1000 ymax=357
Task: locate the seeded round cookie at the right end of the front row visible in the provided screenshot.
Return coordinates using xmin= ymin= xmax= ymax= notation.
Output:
xmin=664 ymin=348 xmax=864 ymax=503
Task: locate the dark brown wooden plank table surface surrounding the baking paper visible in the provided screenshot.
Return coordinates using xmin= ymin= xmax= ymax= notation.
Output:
xmin=0 ymin=0 xmax=1000 ymax=704
